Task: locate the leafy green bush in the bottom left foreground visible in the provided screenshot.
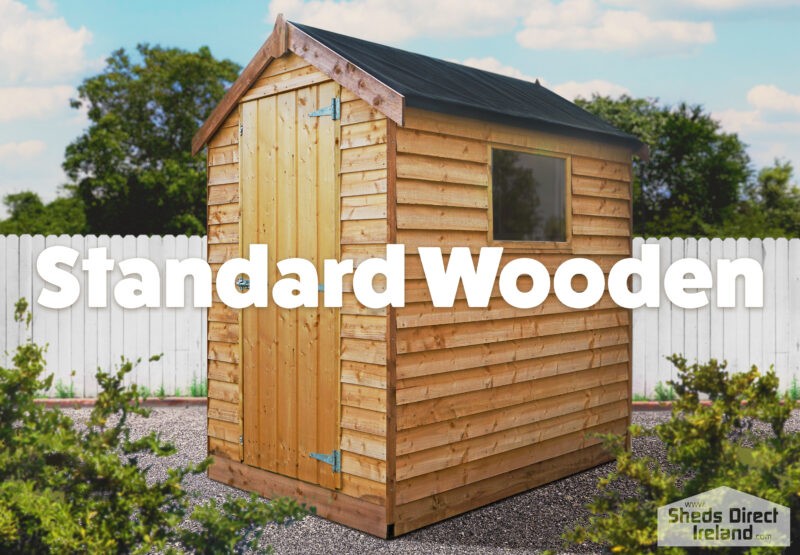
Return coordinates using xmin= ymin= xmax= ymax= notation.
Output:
xmin=0 ymin=300 xmax=307 ymax=554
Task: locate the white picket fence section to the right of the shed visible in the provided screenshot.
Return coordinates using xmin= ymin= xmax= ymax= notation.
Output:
xmin=633 ymin=238 xmax=800 ymax=395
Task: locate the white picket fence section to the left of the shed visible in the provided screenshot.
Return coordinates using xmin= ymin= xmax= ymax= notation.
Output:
xmin=0 ymin=235 xmax=206 ymax=397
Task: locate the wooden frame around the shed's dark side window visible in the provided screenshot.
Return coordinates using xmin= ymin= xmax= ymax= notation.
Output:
xmin=487 ymin=143 xmax=572 ymax=254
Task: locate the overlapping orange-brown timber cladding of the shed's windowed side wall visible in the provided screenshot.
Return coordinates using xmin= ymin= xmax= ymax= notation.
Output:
xmin=389 ymin=109 xmax=631 ymax=533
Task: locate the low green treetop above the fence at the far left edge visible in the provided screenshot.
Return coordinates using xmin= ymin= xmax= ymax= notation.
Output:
xmin=0 ymin=191 xmax=86 ymax=235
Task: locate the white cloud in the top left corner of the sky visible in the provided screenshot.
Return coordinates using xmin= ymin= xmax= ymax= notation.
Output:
xmin=0 ymin=0 xmax=92 ymax=84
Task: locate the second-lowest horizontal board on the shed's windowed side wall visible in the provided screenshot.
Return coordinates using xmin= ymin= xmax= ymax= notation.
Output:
xmin=397 ymin=418 xmax=627 ymax=505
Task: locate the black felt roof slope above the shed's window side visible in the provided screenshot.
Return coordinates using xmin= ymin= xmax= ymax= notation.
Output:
xmin=292 ymin=22 xmax=642 ymax=148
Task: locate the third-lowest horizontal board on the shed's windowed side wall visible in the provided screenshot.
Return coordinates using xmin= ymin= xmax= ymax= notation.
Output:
xmin=397 ymin=401 xmax=628 ymax=481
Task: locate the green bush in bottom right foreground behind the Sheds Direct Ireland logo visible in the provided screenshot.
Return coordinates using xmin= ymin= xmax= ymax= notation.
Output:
xmin=565 ymin=355 xmax=800 ymax=554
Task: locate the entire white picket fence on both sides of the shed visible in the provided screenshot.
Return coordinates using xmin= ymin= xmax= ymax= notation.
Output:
xmin=0 ymin=235 xmax=800 ymax=396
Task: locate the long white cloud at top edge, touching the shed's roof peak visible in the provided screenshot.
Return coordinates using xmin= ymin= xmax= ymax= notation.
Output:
xmin=268 ymin=0 xmax=528 ymax=43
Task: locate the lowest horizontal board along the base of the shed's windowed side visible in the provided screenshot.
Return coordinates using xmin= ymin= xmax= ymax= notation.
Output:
xmin=395 ymin=445 xmax=611 ymax=535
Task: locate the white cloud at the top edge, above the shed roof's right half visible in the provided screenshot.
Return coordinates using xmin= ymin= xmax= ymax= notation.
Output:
xmin=517 ymin=0 xmax=716 ymax=53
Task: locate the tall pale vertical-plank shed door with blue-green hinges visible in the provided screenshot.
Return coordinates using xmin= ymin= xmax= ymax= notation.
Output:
xmin=239 ymin=81 xmax=341 ymax=488
